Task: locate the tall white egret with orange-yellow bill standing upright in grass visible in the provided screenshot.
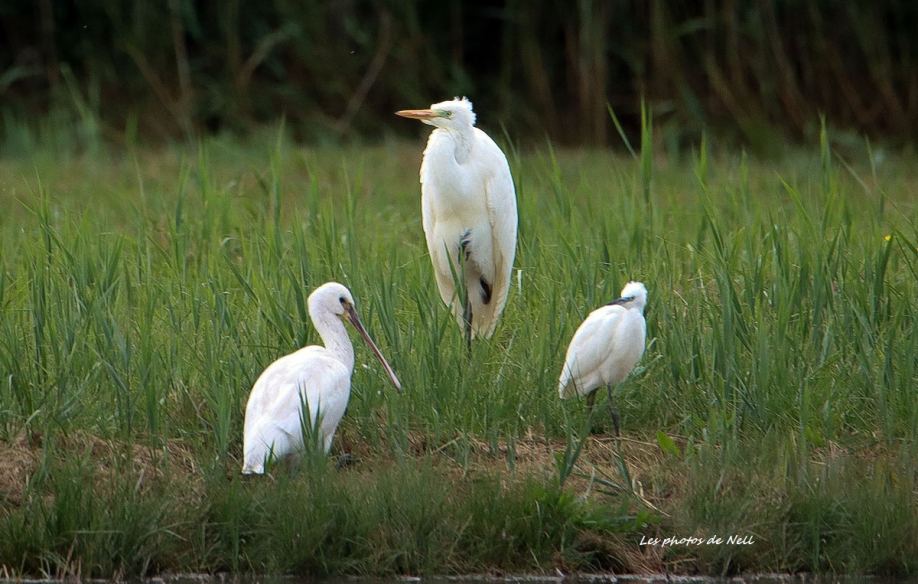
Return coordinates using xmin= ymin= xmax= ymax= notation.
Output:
xmin=396 ymin=98 xmax=517 ymax=343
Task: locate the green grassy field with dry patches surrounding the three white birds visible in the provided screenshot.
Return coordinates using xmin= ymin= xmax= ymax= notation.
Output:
xmin=0 ymin=125 xmax=918 ymax=577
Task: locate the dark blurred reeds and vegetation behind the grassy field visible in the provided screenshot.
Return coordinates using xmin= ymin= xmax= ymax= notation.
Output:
xmin=0 ymin=0 xmax=918 ymax=151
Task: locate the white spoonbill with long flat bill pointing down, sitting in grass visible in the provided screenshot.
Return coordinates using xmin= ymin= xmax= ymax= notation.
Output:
xmin=242 ymin=282 xmax=401 ymax=474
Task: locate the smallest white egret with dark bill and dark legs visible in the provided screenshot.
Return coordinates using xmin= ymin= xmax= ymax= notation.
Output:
xmin=558 ymin=282 xmax=647 ymax=436
